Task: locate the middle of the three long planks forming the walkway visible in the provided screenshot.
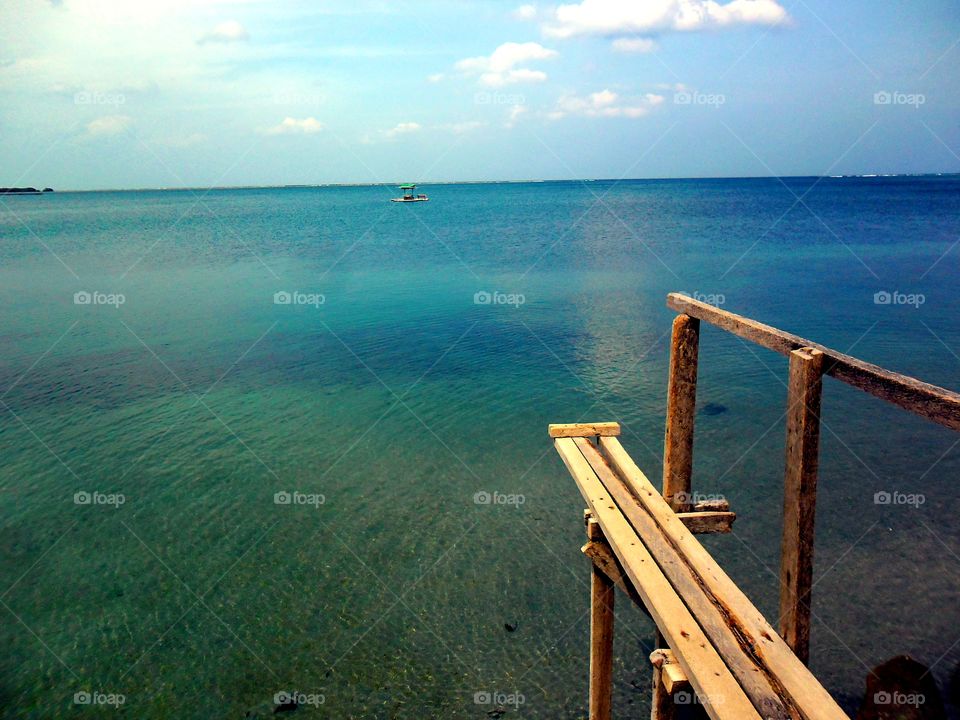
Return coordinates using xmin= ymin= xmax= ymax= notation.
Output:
xmin=573 ymin=438 xmax=801 ymax=720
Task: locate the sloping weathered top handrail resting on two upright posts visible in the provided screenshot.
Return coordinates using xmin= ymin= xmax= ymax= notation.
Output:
xmin=667 ymin=293 xmax=960 ymax=430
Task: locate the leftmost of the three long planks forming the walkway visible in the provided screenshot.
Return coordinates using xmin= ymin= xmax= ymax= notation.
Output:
xmin=554 ymin=438 xmax=760 ymax=720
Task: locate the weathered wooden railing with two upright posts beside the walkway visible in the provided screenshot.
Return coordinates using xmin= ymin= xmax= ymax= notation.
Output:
xmin=663 ymin=293 xmax=960 ymax=662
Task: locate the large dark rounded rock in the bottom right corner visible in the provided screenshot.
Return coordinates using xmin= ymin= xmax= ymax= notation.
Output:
xmin=857 ymin=655 xmax=946 ymax=720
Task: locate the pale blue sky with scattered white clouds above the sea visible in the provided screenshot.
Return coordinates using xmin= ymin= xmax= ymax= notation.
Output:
xmin=0 ymin=0 xmax=960 ymax=190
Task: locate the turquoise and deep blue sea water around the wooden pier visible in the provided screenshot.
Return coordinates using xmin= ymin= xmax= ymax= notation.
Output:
xmin=0 ymin=178 xmax=960 ymax=718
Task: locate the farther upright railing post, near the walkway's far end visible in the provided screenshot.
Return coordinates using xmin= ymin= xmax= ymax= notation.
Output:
xmin=663 ymin=315 xmax=700 ymax=512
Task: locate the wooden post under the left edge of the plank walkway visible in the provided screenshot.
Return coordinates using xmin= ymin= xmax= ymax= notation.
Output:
xmin=586 ymin=517 xmax=614 ymax=720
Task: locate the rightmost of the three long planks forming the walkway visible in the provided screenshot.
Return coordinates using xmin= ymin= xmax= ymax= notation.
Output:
xmin=600 ymin=438 xmax=848 ymax=720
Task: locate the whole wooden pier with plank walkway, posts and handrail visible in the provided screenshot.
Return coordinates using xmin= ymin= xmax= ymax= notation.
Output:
xmin=549 ymin=293 xmax=960 ymax=720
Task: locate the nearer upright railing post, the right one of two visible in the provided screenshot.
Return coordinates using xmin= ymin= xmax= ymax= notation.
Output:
xmin=780 ymin=348 xmax=823 ymax=663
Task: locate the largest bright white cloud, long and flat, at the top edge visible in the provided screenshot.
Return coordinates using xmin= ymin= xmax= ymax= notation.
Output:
xmin=544 ymin=0 xmax=788 ymax=38
